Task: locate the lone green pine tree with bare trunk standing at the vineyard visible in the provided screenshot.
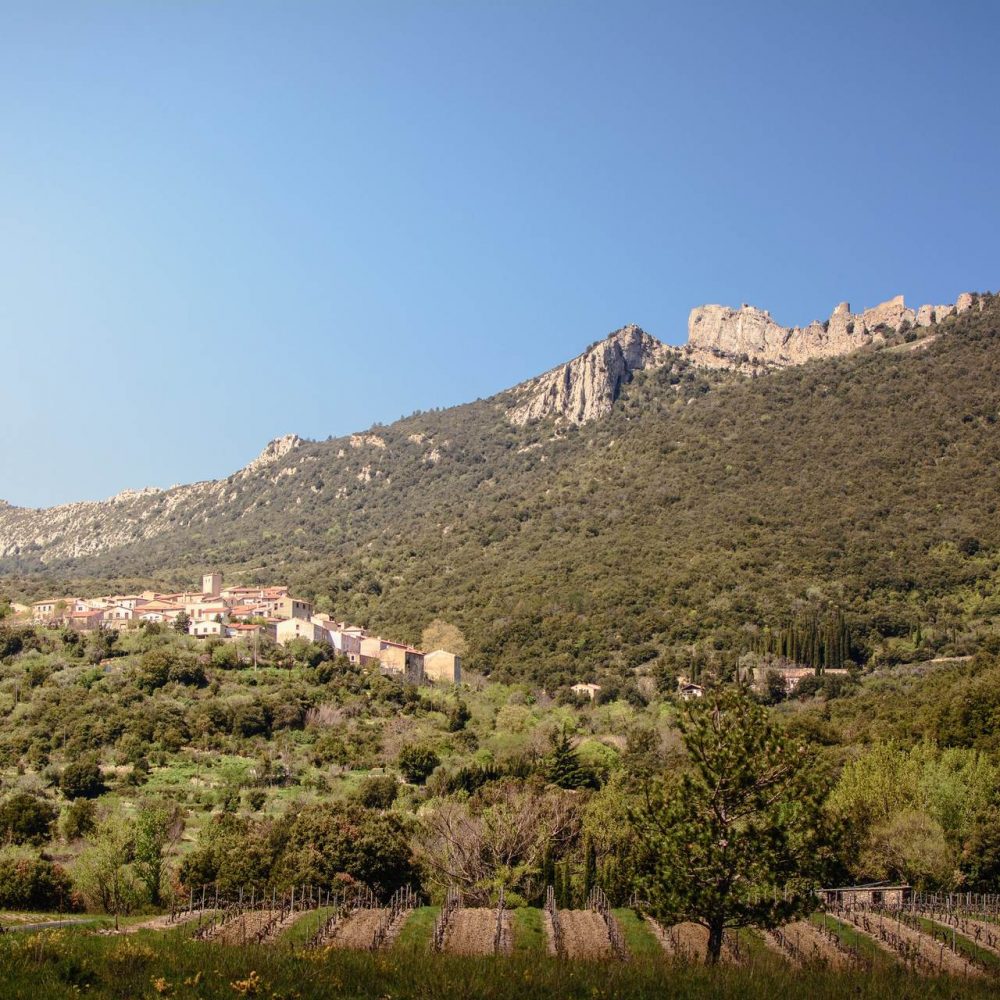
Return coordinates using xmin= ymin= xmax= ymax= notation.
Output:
xmin=632 ymin=688 xmax=827 ymax=964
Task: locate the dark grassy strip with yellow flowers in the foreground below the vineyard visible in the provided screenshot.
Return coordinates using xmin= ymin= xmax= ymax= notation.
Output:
xmin=0 ymin=920 xmax=997 ymax=1000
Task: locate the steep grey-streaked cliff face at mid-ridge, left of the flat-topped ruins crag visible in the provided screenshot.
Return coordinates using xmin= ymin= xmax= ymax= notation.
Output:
xmin=507 ymin=325 xmax=675 ymax=424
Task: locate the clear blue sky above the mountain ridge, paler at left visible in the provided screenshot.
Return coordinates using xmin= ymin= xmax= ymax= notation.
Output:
xmin=0 ymin=0 xmax=1000 ymax=506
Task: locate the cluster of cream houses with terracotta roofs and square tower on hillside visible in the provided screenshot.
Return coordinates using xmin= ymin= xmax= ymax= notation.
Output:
xmin=15 ymin=573 xmax=462 ymax=684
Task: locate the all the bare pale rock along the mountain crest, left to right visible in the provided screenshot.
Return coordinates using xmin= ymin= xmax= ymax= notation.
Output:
xmin=0 ymin=293 xmax=983 ymax=568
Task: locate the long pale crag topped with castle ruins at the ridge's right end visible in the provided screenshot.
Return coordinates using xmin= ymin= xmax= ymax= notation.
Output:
xmin=685 ymin=293 xmax=976 ymax=370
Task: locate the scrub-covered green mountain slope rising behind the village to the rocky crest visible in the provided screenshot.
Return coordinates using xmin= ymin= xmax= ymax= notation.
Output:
xmin=3 ymin=296 xmax=1000 ymax=684
